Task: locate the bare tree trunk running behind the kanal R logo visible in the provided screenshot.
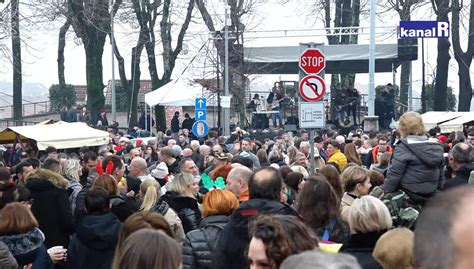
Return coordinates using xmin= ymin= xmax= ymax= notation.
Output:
xmin=431 ymin=0 xmax=451 ymax=111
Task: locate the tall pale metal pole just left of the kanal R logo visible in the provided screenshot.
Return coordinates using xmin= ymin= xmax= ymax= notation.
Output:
xmin=369 ymin=0 xmax=376 ymax=116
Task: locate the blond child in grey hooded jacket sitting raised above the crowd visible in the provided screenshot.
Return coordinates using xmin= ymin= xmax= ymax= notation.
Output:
xmin=381 ymin=112 xmax=444 ymax=206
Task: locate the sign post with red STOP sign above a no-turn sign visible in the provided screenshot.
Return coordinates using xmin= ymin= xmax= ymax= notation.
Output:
xmin=298 ymin=43 xmax=326 ymax=175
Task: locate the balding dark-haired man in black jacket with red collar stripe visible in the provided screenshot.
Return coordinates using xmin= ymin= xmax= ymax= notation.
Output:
xmin=213 ymin=167 xmax=298 ymax=269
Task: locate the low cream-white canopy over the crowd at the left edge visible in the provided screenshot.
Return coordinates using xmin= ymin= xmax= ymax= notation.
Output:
xmin=0 ymin=122 xmax=109 ymax=150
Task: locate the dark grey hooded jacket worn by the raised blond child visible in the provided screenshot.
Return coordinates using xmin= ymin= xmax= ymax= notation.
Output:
xmin=381 ymin=136 xmax=444 ymax=199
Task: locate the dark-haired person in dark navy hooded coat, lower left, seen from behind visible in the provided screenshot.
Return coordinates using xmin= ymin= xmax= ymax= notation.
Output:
xmin=67 ymin=188 xmax=122 ymax=269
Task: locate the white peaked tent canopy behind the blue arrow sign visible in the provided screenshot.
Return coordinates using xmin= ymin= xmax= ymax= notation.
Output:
xmin=145 ymin=80 xmax=216 ymax=106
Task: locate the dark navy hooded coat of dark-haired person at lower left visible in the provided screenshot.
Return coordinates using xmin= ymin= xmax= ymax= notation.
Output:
xmin=67 ymin=212 xmax=122 ymax=269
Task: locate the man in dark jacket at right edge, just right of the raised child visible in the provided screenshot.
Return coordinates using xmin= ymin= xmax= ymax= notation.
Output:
xmin=444 ymin=143 xmax=474 ymax=190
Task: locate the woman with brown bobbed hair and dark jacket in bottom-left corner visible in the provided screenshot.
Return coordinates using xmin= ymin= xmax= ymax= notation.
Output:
xmin=0 ymin=202 xmax=53 ymax=269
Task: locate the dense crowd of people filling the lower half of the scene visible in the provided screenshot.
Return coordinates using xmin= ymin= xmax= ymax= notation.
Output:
xmin=0 ymin=112 xmax=474 ymax=269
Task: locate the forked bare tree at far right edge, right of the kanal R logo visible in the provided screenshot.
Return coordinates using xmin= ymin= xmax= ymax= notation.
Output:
xmin=451 ymin=0 xmax=474 ymax=111
